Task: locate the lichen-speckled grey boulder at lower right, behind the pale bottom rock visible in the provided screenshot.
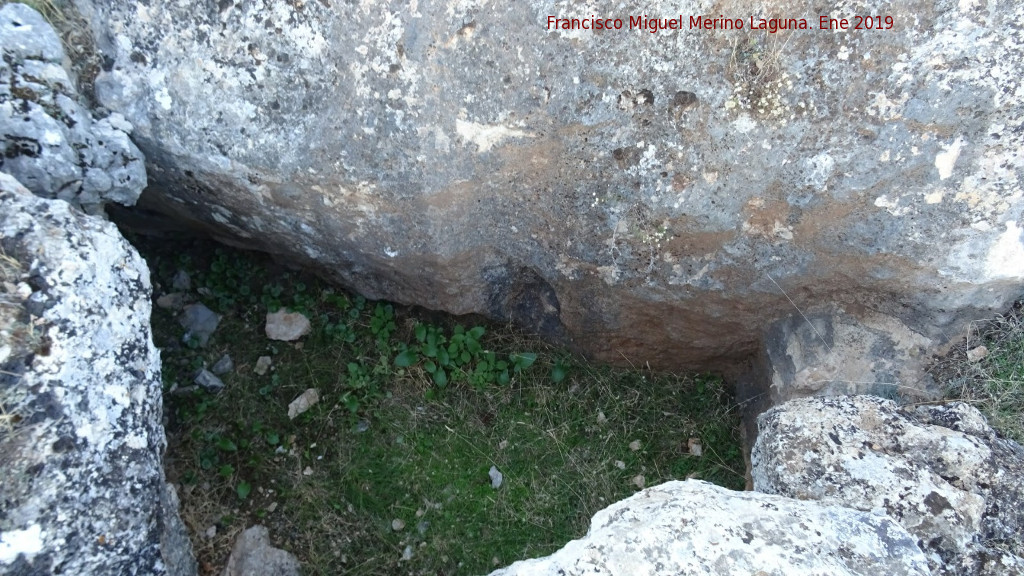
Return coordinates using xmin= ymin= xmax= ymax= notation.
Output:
xmin=752 ymin=397 xmax=1024 ymax=576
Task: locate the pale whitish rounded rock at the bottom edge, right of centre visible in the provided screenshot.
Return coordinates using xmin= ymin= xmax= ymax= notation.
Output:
xmin=492 ymin=480 xmax=929 ymax=576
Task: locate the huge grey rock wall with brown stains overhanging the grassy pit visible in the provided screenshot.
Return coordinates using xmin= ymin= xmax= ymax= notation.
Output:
xmin=70 ymin=0 xmax=1024 ymax=388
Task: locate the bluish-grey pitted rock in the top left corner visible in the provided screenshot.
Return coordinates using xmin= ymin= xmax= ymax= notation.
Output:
xmin=0 ymin=4 xmax=146 ymax=211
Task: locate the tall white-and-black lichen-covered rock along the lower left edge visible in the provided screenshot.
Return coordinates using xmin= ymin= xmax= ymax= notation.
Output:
xmin=0 ymin=174 xmax=196 ymax=576
